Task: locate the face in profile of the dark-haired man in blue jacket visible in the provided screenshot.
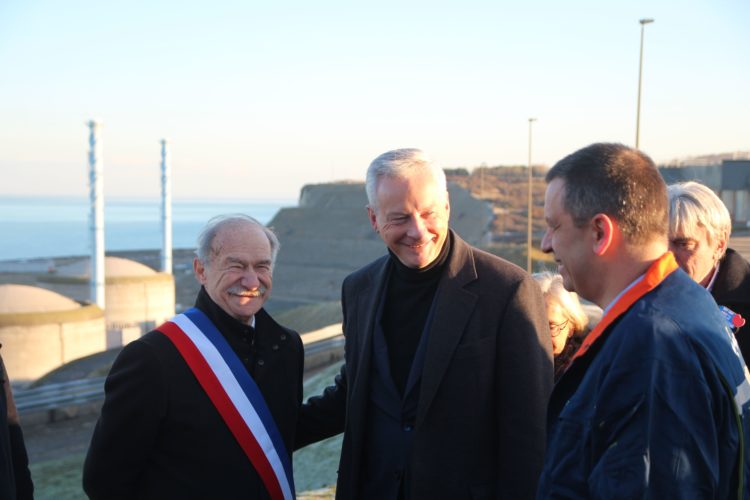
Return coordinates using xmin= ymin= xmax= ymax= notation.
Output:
xmin=542 ymin=177 xmax=594 ymax=300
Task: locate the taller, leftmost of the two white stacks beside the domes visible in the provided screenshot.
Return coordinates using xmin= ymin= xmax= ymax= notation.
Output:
xmin=88 ymin=120 xmax=105 ymax=309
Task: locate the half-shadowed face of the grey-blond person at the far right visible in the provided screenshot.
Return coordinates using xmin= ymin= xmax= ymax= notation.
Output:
xmin=669 ymin=226 xmax=726 ymax=287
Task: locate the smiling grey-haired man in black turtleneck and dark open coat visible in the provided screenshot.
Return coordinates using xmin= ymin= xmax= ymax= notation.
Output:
xmin=297 ymin=149 xmax=552 ymax=500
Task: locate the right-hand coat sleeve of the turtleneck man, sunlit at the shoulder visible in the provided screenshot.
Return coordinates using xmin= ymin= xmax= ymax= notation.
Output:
xmin=497 ymin=275 xmax=553 ymax=498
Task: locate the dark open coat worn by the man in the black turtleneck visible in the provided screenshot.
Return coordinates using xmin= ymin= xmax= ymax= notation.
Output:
xmin=296 ymin=233 xmax=553 ymax=500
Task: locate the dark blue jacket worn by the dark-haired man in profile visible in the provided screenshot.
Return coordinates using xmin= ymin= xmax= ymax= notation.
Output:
xmin=538 ymin=270 xmax=750 ymax=499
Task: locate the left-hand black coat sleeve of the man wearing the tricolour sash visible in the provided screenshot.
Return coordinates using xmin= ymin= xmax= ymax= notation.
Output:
xmin=83 ymin=341 xmax=166 ymax=499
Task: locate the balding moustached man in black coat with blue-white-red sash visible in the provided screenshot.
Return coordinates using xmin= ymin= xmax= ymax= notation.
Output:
xmin=83 ymin=215 xmax=303 ymax=499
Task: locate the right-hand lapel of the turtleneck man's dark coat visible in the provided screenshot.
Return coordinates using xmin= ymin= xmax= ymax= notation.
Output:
xmin=416 ymin=231 xmax=478 ymax=425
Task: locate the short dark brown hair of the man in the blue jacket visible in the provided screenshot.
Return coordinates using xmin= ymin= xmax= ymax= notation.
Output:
xmin=546 ymin=143 xmax=669 ymax=244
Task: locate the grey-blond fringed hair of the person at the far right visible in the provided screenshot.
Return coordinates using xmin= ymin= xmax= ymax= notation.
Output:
xmin=667 ymin=181 xmax=732 ymax=258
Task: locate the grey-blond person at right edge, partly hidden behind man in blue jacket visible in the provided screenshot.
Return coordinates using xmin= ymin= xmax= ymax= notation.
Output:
xmin=667 ymin=181 xmax=750 ymax=364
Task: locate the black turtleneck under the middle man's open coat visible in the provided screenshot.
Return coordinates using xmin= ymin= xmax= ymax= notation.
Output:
xmin=381 ymin=233 xmax=451 ymax=395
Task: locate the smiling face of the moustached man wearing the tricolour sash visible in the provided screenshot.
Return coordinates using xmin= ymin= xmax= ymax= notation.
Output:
xmin=193 ymin=222 xmax=272 ymax=324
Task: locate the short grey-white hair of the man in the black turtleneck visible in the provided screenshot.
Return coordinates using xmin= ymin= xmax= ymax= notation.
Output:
xmin=365 ymin=148 xmax=448 ymax=210
